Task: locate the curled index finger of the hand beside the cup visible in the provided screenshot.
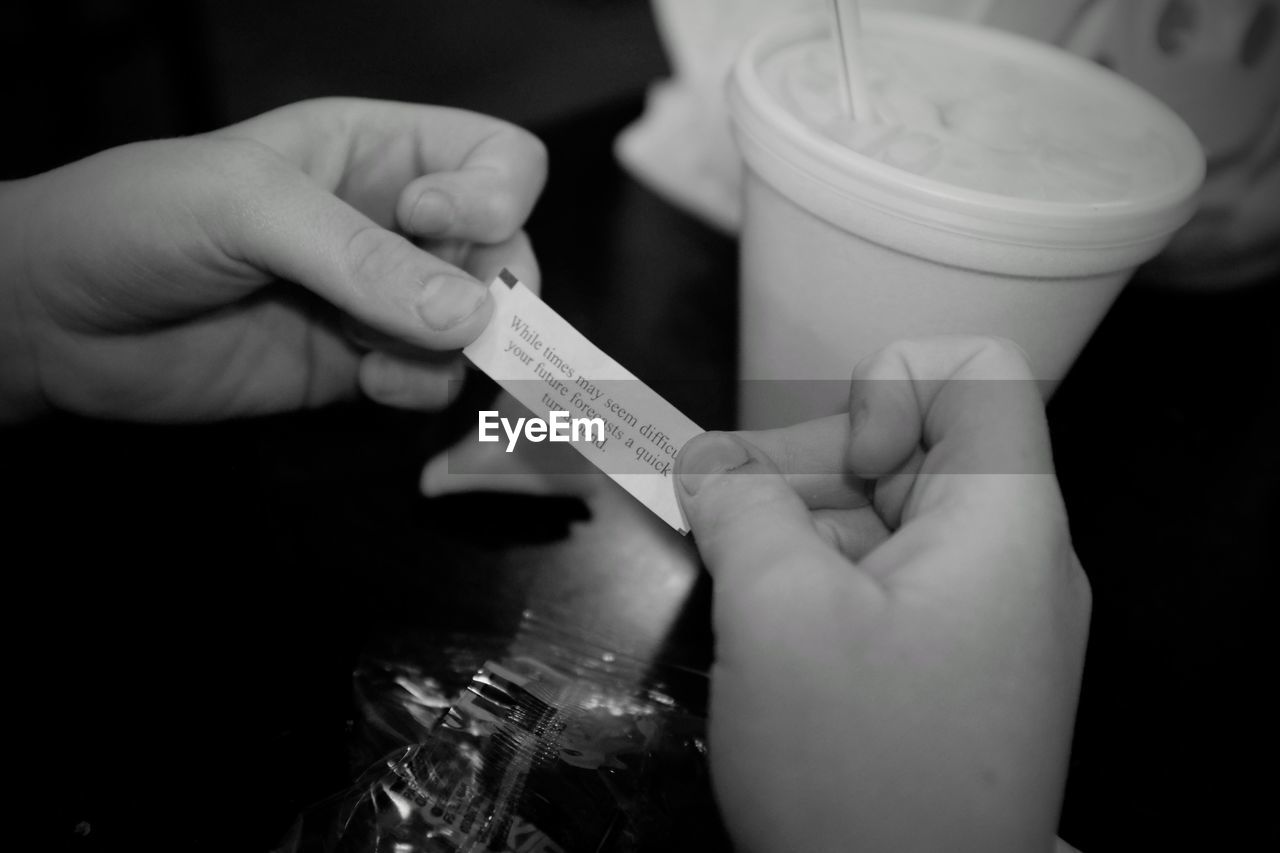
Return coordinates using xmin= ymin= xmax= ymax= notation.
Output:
xmin=849 ymin=337 xmax=1064 ymax=530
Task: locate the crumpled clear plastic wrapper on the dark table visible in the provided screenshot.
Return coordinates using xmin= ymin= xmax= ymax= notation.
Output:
xmin=279 ymin=615 xmax=730 ymax=853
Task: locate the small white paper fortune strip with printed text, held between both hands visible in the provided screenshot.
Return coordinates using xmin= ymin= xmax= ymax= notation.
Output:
xmin=462 ymin=270 xmax=703 ymax=533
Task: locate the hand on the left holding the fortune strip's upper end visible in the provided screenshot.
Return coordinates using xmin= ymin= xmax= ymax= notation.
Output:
xmin=0 ymin=99 xmax=545 ymax=420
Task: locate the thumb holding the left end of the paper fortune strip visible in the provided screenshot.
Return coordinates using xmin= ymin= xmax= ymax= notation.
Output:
xmin=228 ymin=151 xmax=493 ymax=350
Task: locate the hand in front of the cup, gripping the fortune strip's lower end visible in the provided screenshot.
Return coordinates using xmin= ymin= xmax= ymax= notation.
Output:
xmin=677 ymin=338 xmax=1089 ymax=853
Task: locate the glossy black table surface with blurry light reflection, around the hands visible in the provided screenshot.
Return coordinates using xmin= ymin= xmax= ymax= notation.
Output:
xmin=0 ymin=99 xmax=1280 ymax=850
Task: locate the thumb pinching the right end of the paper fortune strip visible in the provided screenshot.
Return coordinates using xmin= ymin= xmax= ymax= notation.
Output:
xmin=676 ymin=433 xmax=836 ymax=587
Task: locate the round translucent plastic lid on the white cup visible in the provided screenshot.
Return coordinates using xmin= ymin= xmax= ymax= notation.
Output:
xmin=730 ymin=13 xmax=1204 ymax=263
